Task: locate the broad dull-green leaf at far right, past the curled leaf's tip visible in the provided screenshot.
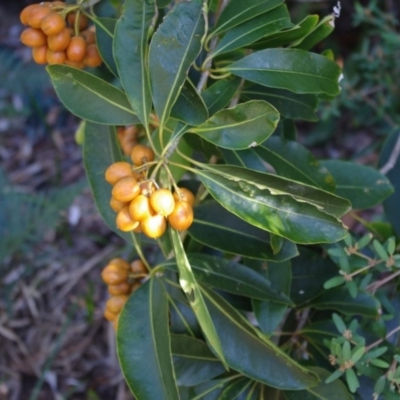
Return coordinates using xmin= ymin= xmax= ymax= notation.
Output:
xmin=321 ymin=160 xmax=393 ymax=209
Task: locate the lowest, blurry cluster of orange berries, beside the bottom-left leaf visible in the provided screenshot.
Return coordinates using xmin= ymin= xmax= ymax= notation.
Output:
xmin=101 ymin=258 xmax=148 ymax=330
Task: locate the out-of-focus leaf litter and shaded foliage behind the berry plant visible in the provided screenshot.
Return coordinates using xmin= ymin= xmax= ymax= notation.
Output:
xmin=0 ymin=0 xmax=400 ymax=400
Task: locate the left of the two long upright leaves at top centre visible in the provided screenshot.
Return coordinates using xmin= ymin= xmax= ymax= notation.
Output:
xmin=114 ymin=0 xmax=156 ymax=126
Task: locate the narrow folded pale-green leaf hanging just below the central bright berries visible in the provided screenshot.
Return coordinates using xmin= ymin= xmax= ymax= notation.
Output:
xmin=169 ymin=228 xmax=225 ymax=363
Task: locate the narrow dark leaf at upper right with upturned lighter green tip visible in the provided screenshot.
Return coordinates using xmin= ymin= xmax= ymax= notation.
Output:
xmin=251 ymin=15 xmax=319 ymax=50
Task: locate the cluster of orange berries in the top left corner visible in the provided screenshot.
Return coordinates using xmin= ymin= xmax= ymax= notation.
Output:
xmin=20 ymin=1 xmax=102 ymax=69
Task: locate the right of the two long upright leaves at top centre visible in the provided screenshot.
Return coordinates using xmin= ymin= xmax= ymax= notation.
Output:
xmin=149 ymin=1 xmax=205 ymax=129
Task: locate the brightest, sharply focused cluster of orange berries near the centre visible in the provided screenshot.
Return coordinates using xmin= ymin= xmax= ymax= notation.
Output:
xmin=105 ymin=144 xmax=195 ymax=239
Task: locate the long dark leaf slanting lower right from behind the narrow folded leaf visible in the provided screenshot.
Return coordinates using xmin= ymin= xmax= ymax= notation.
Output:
xmin=201 ymin=286 xmax=318 ymax=390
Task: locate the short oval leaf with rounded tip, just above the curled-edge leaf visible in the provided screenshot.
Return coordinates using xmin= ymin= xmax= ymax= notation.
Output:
xmin=190 ymin=100 xmax=279 ymax=150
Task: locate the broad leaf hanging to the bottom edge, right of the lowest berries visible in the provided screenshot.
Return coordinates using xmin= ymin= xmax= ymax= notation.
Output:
xmin=117 ymin=277 xmax=179 ymax=400
